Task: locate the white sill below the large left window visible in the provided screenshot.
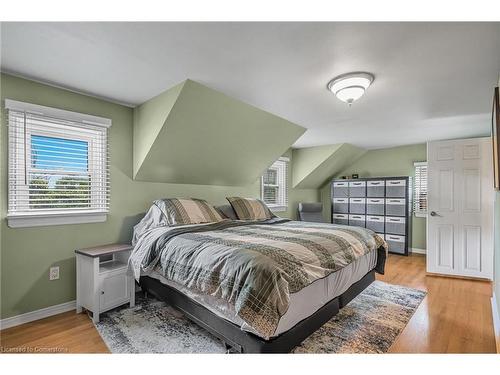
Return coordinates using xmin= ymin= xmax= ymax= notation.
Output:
xmin=7 ymin=211 xmax=107 ymax=228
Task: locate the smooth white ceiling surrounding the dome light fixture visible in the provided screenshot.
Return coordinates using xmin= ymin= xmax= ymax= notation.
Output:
xmin=1 ymin=23 xmax=500 ymax=148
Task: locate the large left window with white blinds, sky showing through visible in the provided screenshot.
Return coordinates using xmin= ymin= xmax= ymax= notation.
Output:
xmin=5 ymin=99 xmax=111 ymax=227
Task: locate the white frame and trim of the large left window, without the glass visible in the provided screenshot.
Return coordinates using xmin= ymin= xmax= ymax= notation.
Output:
xmin=5 ymin=99 xmax=112 ymax=228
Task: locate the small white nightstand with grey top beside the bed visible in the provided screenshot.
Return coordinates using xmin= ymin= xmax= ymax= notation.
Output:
xmin=75 ymin=244 xmax=135 ymax=323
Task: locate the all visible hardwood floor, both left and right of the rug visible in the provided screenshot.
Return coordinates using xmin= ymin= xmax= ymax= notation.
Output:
xmin=0 ymin=255 xmax=496 ymax=353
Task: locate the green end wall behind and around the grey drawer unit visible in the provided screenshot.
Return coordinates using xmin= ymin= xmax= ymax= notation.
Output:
xmin=321 ymin=144 xmax=427 ymax=249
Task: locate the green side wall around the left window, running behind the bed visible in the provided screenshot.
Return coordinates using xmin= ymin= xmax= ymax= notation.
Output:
xmin=0 ymin=74 xmax=319 ymax=319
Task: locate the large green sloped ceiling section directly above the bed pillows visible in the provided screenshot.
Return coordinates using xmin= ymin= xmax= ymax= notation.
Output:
xmin=134 ymin=80 xmax=306 ymax=186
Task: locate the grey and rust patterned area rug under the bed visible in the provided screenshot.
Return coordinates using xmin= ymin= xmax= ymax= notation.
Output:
xmin=96 ymin=281 xmax=426 ymax=353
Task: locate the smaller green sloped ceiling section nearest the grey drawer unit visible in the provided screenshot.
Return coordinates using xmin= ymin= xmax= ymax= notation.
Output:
xmin=292 ymin=143 xmax=367 ymax=189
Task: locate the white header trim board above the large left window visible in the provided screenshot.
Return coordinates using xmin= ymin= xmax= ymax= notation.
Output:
xmin=5 ymin=99 xmax=112 ymax=128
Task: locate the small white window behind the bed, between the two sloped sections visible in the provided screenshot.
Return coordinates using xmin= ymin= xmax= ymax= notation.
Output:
xmin=261 ymin=158 xmax=289 ymax=211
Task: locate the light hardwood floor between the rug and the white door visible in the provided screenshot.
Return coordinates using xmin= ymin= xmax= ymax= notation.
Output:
xmin=377 ymin=254 xmax=496 ymax=353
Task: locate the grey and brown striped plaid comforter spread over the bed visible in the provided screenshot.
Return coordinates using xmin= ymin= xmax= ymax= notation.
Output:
xmin=129 ymin=214 xmax=386 ymax=339
